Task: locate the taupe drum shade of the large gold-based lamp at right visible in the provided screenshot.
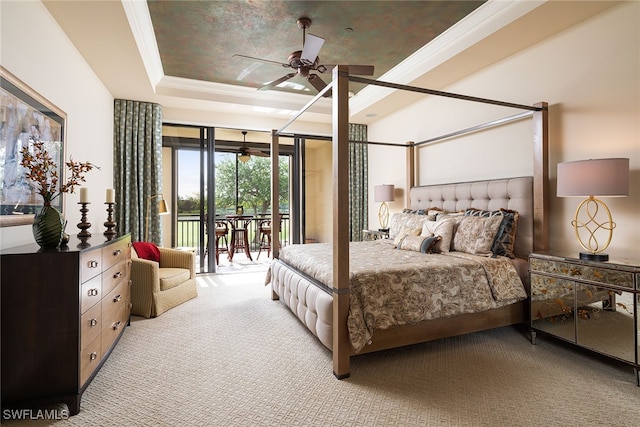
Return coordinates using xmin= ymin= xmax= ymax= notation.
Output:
xmin=556 ymin=158 xmax=629 ymax=197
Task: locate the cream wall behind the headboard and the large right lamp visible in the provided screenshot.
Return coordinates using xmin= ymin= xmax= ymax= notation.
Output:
xmin=369 ymin=2 xmax=640 ymax=259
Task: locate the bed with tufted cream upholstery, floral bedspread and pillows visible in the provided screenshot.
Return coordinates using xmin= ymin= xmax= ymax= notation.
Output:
xmin=268 ymin=177 xmax=533 ymax=362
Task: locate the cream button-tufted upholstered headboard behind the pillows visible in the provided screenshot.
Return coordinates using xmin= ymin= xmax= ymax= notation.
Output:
xmin=410 ymin=177 xmax=533 ymax=259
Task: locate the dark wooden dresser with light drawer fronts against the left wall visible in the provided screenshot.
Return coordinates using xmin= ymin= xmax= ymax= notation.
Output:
xmin=0 ymin=235 xmax=131 ymax=415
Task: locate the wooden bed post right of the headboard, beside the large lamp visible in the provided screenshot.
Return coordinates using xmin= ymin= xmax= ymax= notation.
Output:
xmin=533 ymin=102 xmax=549 ymax=251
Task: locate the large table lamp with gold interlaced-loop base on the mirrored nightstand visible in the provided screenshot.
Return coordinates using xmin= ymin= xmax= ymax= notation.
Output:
xmin=557 ymin=158 xmax=629 ymax=261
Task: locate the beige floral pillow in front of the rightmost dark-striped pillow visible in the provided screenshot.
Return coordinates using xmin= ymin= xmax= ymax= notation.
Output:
xmin=453 ymin=215 xmax=502 ymax=256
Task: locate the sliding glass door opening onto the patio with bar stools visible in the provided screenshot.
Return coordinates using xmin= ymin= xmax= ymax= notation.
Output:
xmin=163 ymin=125 xmax=300 ymax=273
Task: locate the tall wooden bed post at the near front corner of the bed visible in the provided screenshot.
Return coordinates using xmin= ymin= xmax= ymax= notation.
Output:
xmin=332 ymin=65 xmax=351 ymax=379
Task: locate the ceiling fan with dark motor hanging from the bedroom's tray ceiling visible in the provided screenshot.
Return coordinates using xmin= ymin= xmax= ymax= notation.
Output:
xmin=233 ymin=17 xmax=373 ymax=97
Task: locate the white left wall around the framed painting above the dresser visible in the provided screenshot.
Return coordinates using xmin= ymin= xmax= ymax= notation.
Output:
xmin=0 ymin=0 xmax=117 ymax=248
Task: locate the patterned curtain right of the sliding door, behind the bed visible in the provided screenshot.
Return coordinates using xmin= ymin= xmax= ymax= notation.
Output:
xmin=349 ymin=123 xmax=369 ymax=242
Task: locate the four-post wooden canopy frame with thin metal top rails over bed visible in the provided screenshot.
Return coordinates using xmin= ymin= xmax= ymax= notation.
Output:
xmin=271 ymin=65 xmax=549 ymax=379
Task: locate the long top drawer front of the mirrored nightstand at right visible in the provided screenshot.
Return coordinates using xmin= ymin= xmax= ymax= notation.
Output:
xmin=529 ymin=258 xmax=635 ymax=289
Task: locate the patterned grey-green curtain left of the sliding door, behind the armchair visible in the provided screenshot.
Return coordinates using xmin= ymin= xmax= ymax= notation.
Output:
xmin=113 ymin=99 xmax=162 ymax=245
